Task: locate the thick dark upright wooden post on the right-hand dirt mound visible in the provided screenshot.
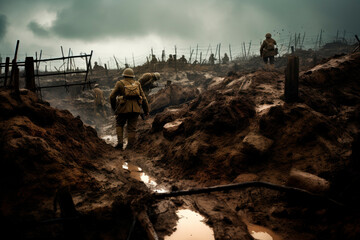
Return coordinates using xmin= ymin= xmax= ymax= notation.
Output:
xmin=284 ymin=56 xmax=299 ymax=102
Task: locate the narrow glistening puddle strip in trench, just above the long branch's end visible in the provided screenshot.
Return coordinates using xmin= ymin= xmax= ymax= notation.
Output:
xmin=122 ymin=162 xmax=168 ymax=193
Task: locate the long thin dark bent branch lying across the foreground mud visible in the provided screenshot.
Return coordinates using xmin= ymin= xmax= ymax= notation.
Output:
xmin=154 ymin=181 xmax=343 ymax=207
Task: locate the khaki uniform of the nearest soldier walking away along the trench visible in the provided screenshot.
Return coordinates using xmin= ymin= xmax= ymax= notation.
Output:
xmin=110 ymin=78 xmax=149 ymax=148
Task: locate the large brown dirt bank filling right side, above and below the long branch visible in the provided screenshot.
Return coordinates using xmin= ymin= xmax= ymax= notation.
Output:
xmin=134 ymin=53 xmax=360 ymax=239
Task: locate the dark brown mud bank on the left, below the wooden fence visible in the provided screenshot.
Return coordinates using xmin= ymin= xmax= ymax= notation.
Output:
xmin=0 ymin=90 xmax=109 ymax=211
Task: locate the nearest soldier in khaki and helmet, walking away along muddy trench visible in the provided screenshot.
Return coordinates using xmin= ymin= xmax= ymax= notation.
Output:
xmin=110 ymin=68 xmax=149 ymax=149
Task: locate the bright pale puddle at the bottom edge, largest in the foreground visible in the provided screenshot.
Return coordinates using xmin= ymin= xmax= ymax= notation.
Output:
xmin=164 ymin=209 xmax=214 ymax=240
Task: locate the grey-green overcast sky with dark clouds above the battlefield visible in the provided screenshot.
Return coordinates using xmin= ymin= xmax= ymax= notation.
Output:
xmin=0 ymin=0 xmax=360 ymax=67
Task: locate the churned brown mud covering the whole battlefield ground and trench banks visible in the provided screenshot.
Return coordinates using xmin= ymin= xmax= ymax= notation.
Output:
xmin=0 ymin=43 xmax=360 ymax=239
